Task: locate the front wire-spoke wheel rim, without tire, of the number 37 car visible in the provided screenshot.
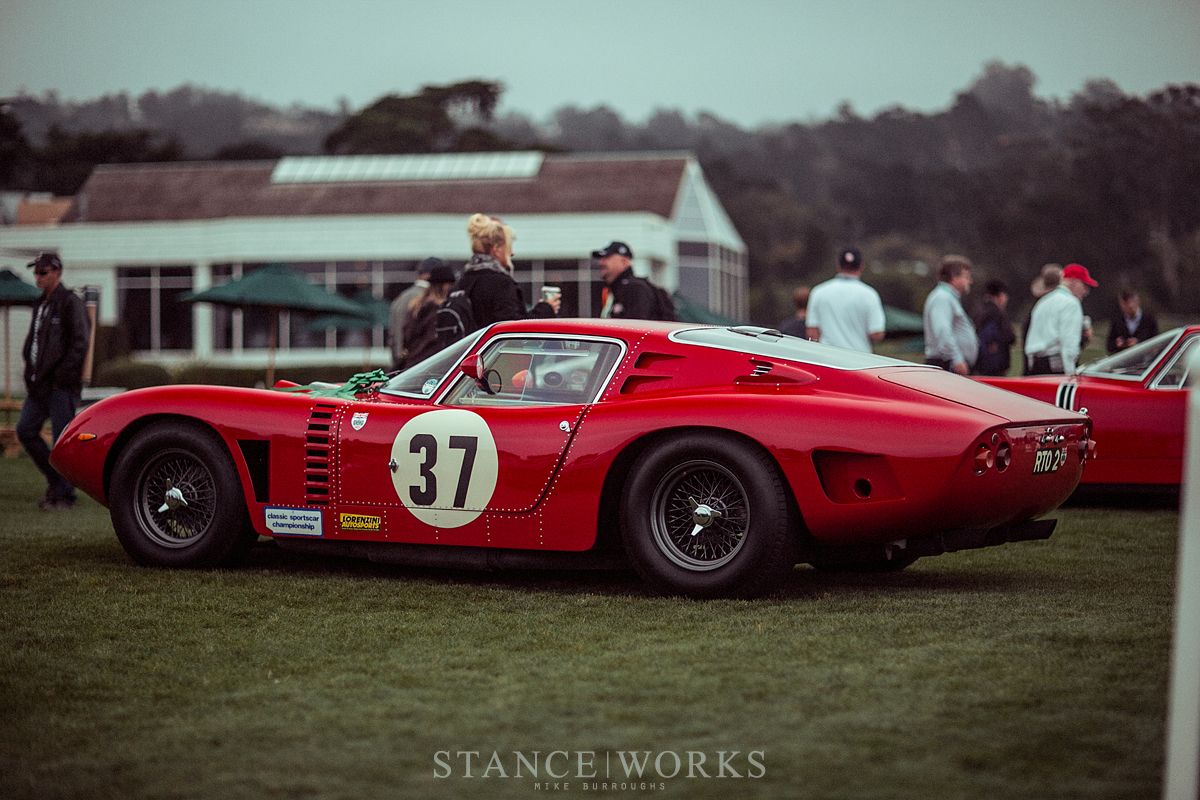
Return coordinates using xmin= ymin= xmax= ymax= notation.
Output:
xmin=134 ymin=449 xmax=217 ymax=548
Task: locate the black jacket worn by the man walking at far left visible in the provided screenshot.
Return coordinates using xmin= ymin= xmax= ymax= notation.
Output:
xmin=23 ymin=283 xmax=89 ymax=396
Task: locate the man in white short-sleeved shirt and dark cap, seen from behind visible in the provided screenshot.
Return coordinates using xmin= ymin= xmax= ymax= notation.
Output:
xmin=804 ymin=247 xmax=883 ymax=353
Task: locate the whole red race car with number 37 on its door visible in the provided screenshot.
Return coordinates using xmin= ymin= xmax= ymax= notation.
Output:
xmin=53 ymin=320 xmax=1091 ymax=596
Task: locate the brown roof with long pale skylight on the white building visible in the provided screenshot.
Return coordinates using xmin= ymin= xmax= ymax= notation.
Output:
xmin=62 ymin=154 xmax=690 ymax=222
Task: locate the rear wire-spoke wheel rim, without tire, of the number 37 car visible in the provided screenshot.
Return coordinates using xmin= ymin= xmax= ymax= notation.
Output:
xmin=649 ymin=459 xmax=750 ymax=572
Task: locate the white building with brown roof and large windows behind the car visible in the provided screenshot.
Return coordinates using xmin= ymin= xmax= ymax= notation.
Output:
xmin=0 ymin=151 xmax=748 ymax=381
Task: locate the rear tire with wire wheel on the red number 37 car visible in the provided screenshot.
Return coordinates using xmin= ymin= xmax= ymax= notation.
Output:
xmin=620 ymin=432 xmax=796 ymax=597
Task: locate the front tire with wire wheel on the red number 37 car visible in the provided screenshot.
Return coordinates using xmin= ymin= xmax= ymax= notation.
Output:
xmin=108 ymin=422 xmax=258 ymax=567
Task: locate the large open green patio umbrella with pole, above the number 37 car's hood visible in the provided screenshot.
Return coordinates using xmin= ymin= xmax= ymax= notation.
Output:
xmin=180 ymin=264 xmax=367 ymax=386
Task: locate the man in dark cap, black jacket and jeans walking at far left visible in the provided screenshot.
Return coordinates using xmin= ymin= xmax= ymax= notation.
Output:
xmin=17 ymin=253 xmax=88 ymax=511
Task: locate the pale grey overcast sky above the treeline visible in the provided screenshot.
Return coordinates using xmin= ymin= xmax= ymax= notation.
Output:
xmin=0 ymin=0 xmax=1200 ymax=126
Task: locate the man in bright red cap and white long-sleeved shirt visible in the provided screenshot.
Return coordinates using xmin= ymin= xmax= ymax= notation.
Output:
xmin=1025 ymin=264 xmax=1099 ymax=375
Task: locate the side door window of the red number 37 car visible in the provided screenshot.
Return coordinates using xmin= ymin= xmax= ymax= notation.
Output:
xmin=443 ymin=337 xmax=620 ymax=405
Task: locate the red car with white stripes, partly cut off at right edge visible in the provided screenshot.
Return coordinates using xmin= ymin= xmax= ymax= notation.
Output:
xmin=979 ymin=325 xmax=1200 ymax=488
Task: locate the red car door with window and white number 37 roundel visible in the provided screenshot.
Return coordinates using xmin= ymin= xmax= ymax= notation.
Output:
xmin=335 ymin=336 xmax=623 ymax=546
